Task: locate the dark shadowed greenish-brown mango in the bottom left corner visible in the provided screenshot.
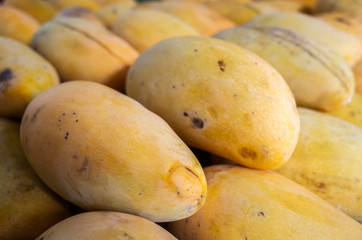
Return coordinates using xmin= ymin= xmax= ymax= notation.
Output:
xmin=0 ymin=118 xmax=69 ymax=240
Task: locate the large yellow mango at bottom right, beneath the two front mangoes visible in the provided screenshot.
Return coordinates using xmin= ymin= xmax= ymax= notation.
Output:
xmin=168 ymin=165 xmax=362 ymax=240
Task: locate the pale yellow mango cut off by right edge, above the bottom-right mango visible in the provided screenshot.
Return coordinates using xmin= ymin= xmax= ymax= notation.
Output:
xmin=276 ymin=108 xmax=362 ymax=221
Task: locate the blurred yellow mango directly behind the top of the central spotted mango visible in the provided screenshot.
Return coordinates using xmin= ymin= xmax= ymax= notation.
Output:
xmin=112 ymin=9 xmax=199 ymax=52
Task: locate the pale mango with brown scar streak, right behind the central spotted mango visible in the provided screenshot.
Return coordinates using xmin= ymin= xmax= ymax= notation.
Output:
xmin=214 ymin=25 xmax=354 ymax=111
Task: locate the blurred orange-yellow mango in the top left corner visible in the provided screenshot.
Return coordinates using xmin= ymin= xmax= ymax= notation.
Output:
xmin=0 ymin=5 xmax=40 ymax=44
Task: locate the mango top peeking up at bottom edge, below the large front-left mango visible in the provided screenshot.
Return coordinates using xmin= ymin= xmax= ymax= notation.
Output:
xmin=36 ymin=211 xmax=177 ymax=240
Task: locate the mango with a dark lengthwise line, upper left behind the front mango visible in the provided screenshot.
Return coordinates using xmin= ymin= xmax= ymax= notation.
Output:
xmin=32 ymin=17 xmax=138 ymax=91
